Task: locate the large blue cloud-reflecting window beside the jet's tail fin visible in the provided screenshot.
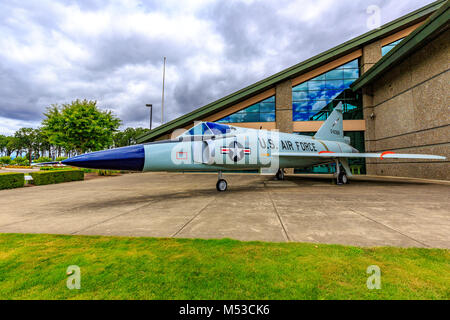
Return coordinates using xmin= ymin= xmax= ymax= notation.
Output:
xmin=292 ymin=59 xmax=362 ymax=121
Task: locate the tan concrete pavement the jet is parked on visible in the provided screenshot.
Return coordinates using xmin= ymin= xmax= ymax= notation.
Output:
xmin=0 ymin=173 xmax=450 ymax=248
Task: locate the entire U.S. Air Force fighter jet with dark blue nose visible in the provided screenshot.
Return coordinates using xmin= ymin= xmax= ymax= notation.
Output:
xmin=62 ymin=103 xmax=445 ymax=191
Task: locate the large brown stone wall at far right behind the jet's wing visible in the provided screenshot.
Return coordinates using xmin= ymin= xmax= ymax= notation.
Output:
xmin=364 ymin=30 xmax=450 ymax=180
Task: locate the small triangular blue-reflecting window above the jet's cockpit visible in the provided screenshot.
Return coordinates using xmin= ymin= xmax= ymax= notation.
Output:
xmin=217 ymin=96 xmax=275 ymax=123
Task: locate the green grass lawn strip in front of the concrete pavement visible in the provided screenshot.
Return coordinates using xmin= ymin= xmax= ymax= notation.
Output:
xmin=0 ymin=234 xmax=450 ymax=299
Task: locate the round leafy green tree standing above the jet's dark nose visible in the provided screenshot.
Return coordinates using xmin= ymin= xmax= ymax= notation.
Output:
xmin=42 ymin=100 xmax=121 ymax=153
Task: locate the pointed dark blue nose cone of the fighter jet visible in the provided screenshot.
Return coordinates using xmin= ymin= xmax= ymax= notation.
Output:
xmin=61 ymin=145 xmax=145 ymax=171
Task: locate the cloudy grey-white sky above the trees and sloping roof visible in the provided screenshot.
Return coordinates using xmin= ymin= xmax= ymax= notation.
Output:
xmin=0 ymin=0 xmax=431 ymax=134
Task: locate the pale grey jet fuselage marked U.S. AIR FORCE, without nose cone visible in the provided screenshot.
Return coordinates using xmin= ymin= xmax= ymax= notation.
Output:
xmin=143 ymin=129 xmax=357 ymax=171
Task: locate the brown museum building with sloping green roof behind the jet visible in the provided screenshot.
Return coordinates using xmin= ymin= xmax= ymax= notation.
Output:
xmin=139 ymin=1 xmax=450 ymax=180
